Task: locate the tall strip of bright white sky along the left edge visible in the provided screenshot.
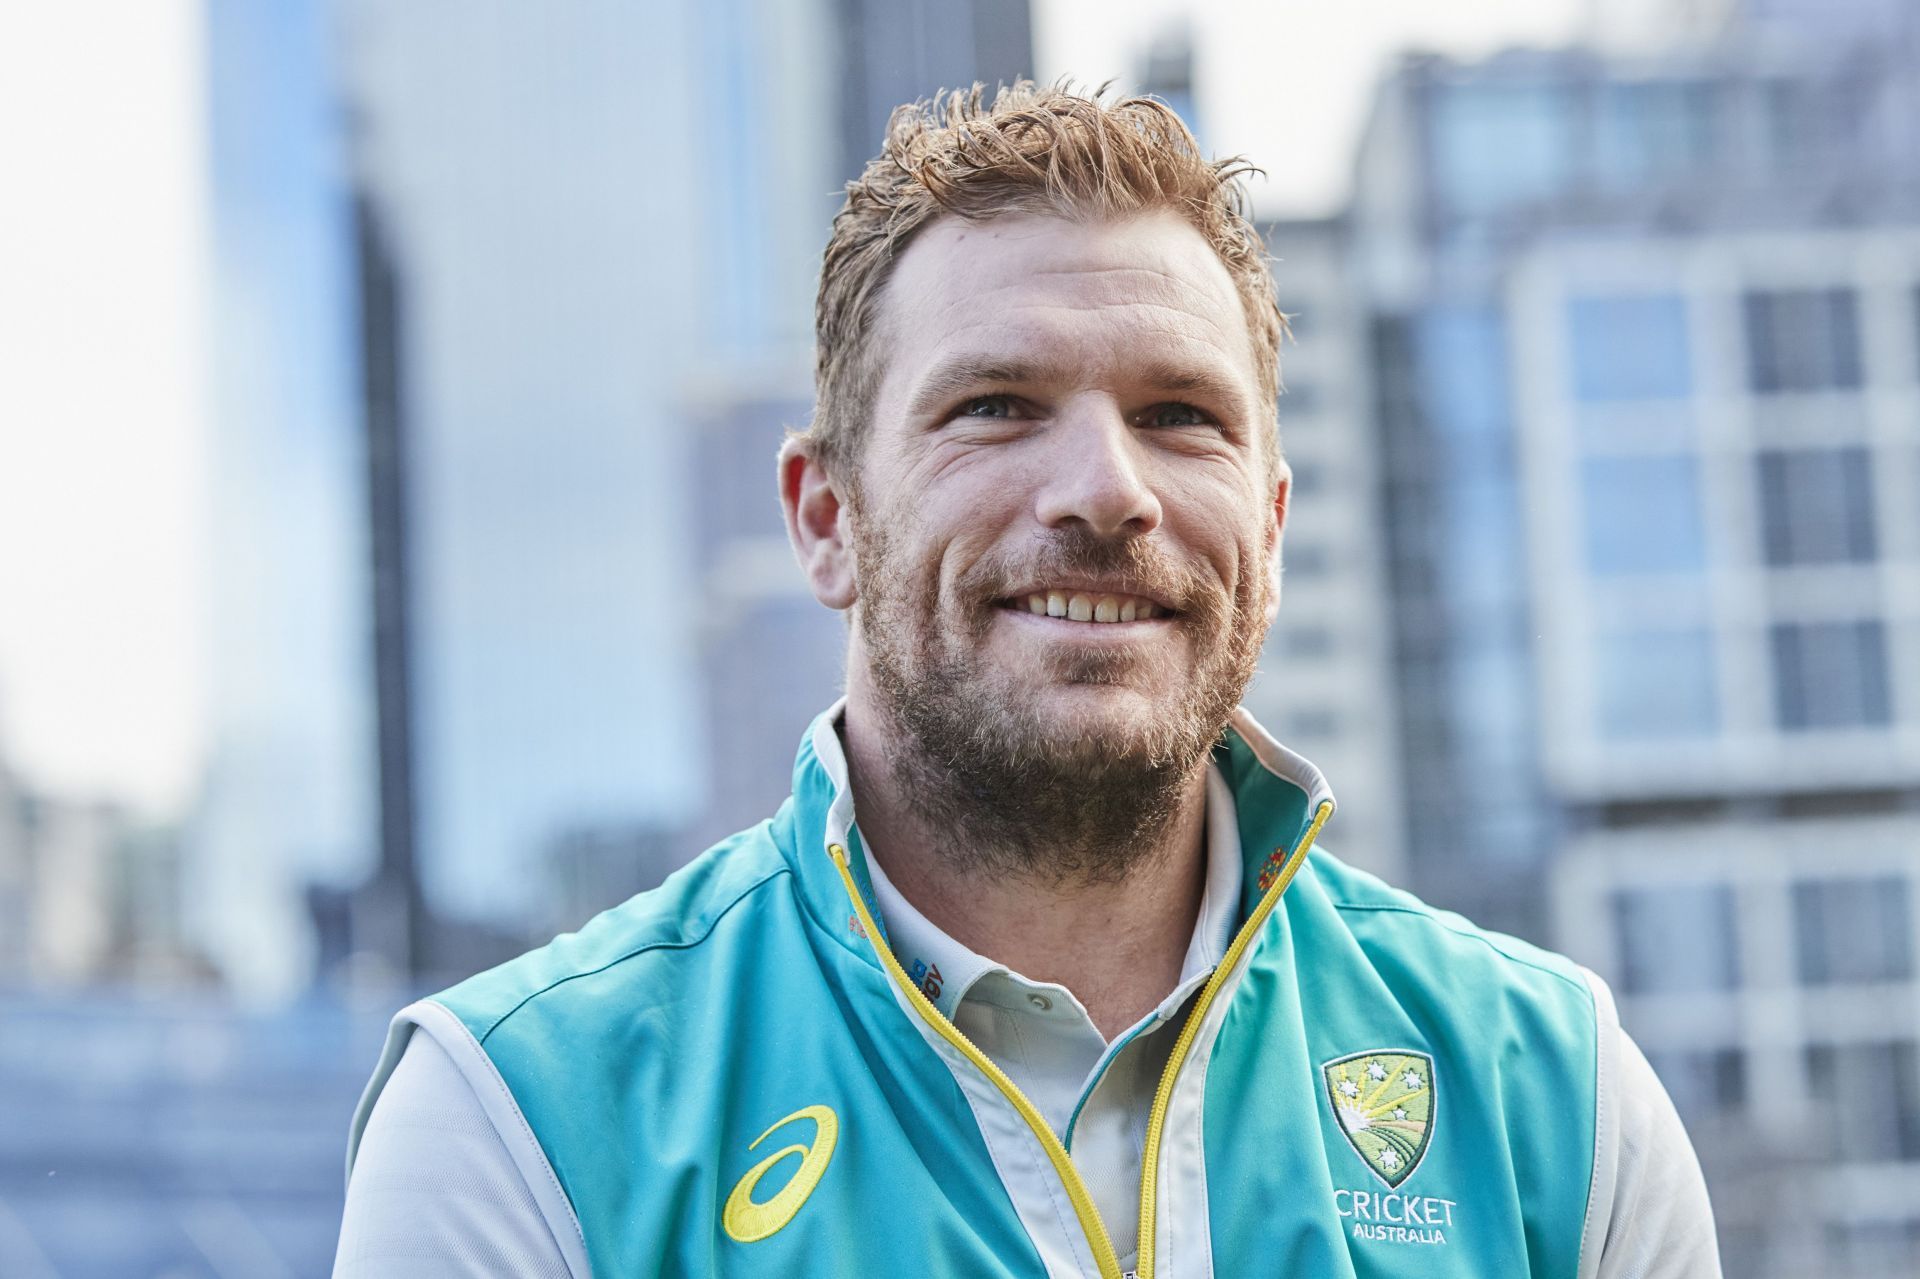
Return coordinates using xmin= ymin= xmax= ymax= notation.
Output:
xmin=0 ymin=0 xmax=207 ymax=812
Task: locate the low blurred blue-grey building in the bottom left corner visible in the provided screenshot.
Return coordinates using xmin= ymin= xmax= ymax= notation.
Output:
xmin=0 ymin=989 xmax=392 ymax=1279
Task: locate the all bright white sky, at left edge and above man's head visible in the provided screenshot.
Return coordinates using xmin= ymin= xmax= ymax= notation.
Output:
xmin=0 ymin=0 xmax=1620 ymax=814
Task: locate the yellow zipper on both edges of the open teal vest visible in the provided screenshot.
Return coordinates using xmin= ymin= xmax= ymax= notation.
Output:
xmin=828 ymin=801 xmax=1332 ymax=1279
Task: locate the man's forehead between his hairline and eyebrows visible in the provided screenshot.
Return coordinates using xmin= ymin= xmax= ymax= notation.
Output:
xmin=877 ymin=209 xmax=1258 ymax=399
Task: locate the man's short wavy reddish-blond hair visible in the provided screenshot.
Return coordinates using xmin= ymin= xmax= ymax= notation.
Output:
xmin=801 ymin=81 xmax=1286 ymax=490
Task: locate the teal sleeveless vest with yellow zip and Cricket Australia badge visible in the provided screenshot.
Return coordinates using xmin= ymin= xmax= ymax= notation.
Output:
xmin=349 ymin=714 xmax=1605 ymax=1279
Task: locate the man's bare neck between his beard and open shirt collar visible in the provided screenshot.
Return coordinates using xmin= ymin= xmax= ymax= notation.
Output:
xmin=843 ymin=672 xmax=1206 ymax=1039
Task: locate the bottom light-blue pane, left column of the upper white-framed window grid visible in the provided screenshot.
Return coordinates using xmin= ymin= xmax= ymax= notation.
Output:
xmin=1594 ymin=630 xmax=1720 ymax=739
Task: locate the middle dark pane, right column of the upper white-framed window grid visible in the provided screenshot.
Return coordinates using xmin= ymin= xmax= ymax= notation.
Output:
xmin=1757 ymin=447 xmax=1874 ymax=565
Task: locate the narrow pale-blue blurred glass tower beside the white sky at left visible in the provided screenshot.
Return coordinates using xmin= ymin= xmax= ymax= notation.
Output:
xmin=184 ymin=0 xmax=374 ymax=1002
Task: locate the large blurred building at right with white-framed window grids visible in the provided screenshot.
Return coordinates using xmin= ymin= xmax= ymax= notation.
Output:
xmin=1352 ymin=4 xmax=1920 ymax=1275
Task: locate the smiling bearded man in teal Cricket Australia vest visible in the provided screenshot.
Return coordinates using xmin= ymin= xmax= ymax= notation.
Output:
xmin=336 ymin=83 xmax=1718 ymax=1279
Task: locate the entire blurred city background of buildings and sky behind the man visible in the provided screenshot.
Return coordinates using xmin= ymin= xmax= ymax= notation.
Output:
xmin=0 ymin=0 xmax=1920 ymax=1279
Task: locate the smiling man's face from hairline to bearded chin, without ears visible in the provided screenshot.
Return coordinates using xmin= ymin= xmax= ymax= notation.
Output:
xmin=851 ymin=213 xmax=1286 ymax=784
